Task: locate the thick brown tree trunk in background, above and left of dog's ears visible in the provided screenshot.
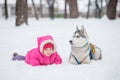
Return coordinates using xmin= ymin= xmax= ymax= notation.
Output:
xmin=68 ymin=0 xmax=79 ymax=18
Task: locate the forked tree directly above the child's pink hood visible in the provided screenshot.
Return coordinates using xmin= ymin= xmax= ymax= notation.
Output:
xmin=47 ymin=0 xmax=55 ymax=19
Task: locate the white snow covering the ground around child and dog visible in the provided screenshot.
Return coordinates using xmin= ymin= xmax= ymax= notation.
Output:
xmin=0 ymin=17 xmax=120 ymax=80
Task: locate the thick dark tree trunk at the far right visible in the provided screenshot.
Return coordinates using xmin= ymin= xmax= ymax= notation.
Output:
xmin=107 ymin=0 xmax=118 ymax=20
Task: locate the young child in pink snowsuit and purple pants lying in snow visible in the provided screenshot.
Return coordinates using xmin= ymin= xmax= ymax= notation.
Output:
xmin=12 ymin=35 xmax=62 ymax=66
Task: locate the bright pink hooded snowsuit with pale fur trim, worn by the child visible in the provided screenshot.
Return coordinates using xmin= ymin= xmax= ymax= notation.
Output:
xmin=25 ymin=35 xmax=62 ymax=66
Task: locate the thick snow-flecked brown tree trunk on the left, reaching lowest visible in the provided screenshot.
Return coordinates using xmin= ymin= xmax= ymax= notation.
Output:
xmin=16 ymin=0 xmax=28 ymax=26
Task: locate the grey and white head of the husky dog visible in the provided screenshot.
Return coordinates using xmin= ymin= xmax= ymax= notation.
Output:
xmin=69 ymin=26 xmax=89 ymax=47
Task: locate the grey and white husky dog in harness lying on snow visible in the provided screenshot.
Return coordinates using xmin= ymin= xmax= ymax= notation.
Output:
xmin=69 ymin=26 xmax=102 ymax=64
